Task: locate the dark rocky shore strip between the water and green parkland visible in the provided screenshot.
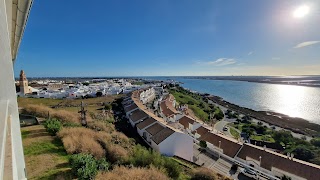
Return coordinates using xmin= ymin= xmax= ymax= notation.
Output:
xmin=207 ymin=95 xmax=320 ymax=137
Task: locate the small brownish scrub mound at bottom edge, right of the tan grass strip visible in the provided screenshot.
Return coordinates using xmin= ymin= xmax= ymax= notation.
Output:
xmin=191 ymin=167 xmax=231 ymax=180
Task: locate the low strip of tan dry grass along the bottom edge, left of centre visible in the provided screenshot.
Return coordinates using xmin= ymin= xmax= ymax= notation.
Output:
xmin=96 ymin=166 xmax=169 ymax=180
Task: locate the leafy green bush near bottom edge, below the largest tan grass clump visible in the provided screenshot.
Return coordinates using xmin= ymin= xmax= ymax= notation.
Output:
xmin=70 ymin=154 xmax=98 ymax=180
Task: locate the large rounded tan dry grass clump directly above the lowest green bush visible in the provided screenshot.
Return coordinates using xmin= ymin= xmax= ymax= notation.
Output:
xmin=58 ymin=127 xmax=105 ymax=159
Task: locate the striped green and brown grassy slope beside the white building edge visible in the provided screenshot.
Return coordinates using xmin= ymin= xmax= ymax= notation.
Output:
xmin=21 ymin=125 xmax=72 ymax=179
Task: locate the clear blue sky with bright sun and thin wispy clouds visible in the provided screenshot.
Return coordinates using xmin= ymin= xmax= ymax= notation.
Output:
xmin=14 ymin=0 xmax=320 ymax=77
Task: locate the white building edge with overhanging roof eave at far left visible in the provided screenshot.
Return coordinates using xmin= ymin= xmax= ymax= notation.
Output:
xmin=0 ymin=0 xmax=33 ymax=180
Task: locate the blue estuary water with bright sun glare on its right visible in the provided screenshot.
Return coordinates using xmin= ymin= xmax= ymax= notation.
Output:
xmin=152 ymin=77 xmax=320 ymax=124
